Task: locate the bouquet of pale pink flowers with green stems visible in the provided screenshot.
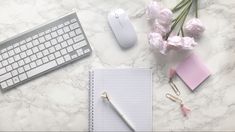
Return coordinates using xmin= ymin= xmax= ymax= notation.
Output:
xmin=146 ymin=0 xmax=205 ymax=55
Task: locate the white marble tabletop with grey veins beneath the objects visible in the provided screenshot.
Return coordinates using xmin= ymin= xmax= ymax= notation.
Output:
xmin=0 ymin=0 xmax=235 ymax=131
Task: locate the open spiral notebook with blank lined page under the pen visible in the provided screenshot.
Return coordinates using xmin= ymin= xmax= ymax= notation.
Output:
xmin=89 ymin=69 xmax=152 ymax=131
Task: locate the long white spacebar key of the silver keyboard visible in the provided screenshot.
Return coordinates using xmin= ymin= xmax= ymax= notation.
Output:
xmin=26 ymin=61 xmax=57 ymax=77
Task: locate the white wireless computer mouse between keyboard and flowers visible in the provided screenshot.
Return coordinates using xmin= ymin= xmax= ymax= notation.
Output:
xmin=108 ymin=9 xmax=137 ymax=48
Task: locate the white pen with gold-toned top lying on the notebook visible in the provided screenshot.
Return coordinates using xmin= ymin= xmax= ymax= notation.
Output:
xmin=101 ymin=92 xmax=135 ymax=132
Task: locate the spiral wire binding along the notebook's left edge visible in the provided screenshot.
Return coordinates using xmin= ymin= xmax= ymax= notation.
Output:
xmin=88 ymin=71 xmax=94 ymax=131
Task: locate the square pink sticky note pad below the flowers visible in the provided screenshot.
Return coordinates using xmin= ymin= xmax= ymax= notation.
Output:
xmin=176 ymin=54 xmax=211 ymax=91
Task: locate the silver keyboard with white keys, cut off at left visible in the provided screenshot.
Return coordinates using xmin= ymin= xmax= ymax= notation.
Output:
xmin=0 ymin=12 xmax=91 ymax=91
